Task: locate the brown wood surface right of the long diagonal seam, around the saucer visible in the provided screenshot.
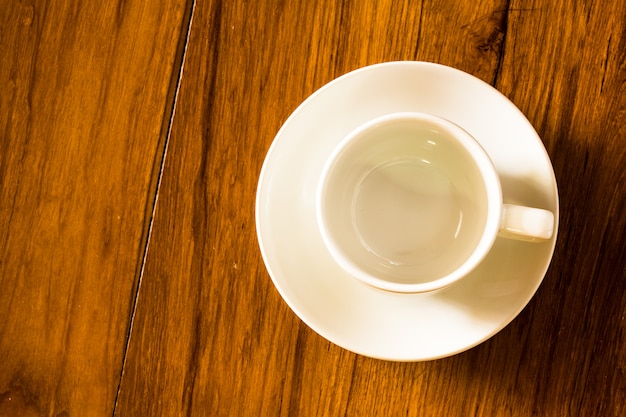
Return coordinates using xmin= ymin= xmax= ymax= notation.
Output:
xmin=116 ymin=1 xmax=626 ymax=416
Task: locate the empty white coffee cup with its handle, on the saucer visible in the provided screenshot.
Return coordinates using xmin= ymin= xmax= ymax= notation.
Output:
xmin=316 ymin=113 xmax=554 ymax=293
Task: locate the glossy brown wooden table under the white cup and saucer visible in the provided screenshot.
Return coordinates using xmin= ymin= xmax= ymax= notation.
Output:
xmin=0 ymin=0 xmax=626 ymax=417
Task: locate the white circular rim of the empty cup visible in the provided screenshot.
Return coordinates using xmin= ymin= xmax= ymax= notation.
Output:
xmin=315 ymin=111 xmax=502 ymax=293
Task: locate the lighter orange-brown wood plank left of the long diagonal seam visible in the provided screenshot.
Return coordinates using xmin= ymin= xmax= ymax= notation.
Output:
xmin=0 ymin=0 xmax=186 ymax=417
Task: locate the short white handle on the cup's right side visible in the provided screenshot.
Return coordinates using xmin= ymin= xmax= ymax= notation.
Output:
xmin=498 ymin=204 xmax=554 ymax=242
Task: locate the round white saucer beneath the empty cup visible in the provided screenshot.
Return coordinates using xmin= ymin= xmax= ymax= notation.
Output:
xmin=256 ymin=62 xmax=558 ymax=361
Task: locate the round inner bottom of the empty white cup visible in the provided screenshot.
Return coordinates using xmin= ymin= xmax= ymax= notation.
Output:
xmin=352 ymin=158 xmax=485 ymax=283
